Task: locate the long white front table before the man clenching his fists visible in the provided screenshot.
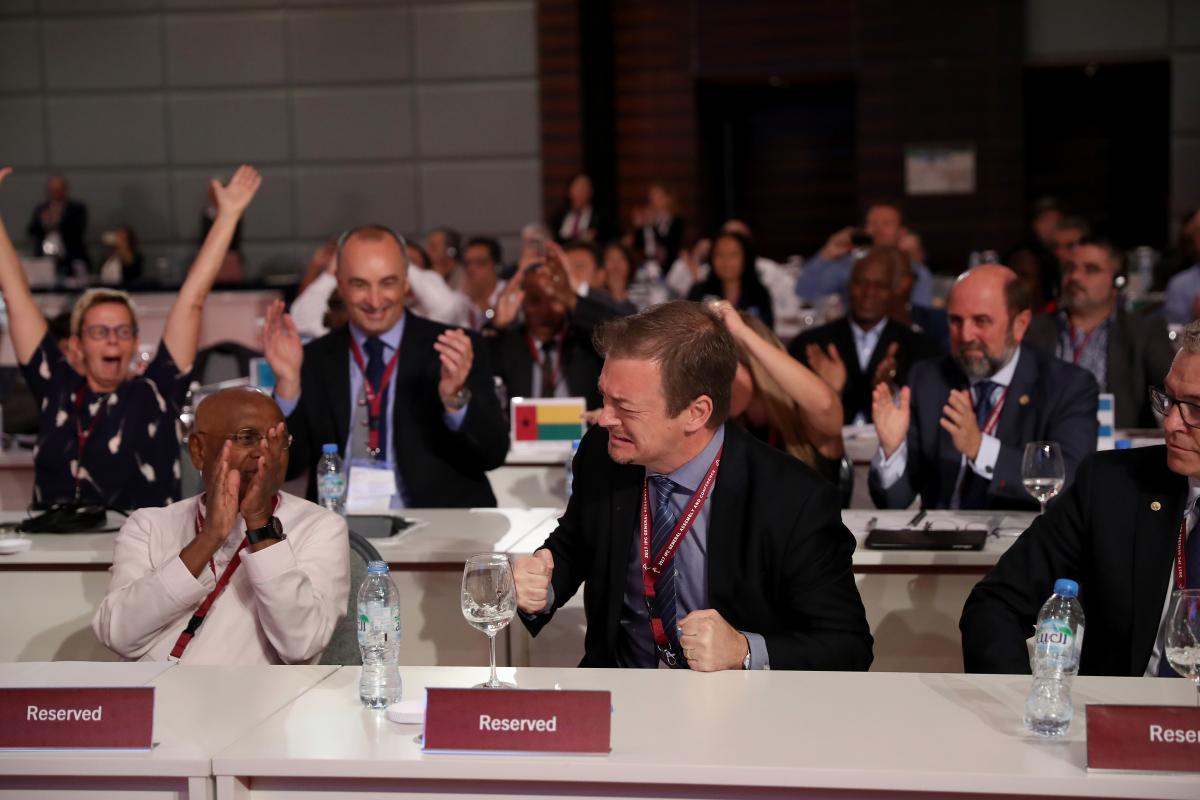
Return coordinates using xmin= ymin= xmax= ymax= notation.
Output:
xmin=212 ymin=667 xmax=1200 ymax=800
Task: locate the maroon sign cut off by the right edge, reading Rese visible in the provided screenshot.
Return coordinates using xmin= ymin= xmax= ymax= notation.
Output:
xmin=1087 ymin=705 xmax=1200 ymax=772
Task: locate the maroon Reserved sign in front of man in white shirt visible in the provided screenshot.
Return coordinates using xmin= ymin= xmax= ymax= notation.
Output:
xmin=0 ymin=686 xmax=154 ymax=750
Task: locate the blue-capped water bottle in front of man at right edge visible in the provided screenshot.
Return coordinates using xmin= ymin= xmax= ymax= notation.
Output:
xmin=1025 ymin=578 xmax=1084 ymax=736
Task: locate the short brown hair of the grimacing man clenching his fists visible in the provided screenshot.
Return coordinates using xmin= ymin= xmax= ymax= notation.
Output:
xmin=594 ymin=300 xmax=738 ymax=428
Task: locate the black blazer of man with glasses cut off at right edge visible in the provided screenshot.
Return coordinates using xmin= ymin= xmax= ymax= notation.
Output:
xmin=959 ymin=445 xmax=1188 ymax=676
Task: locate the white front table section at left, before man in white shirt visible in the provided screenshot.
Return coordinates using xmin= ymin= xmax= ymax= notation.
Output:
xmin=0 ymin=661 xmax=336 ymax=800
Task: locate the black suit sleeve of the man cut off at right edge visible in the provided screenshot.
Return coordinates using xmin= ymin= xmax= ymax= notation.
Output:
xmin=959 ymin=458 xmax=1096 ymax=674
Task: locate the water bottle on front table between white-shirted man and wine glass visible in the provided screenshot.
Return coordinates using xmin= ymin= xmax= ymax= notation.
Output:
xmin=359 ymin=561 xmax=401 ymax=709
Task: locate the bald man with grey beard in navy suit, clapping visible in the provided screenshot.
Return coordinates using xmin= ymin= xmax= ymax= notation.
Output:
xmin=869 ymin=265 xmax=1097 ymax=509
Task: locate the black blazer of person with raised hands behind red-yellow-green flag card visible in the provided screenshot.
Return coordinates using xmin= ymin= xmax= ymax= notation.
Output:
xmin=486 ymin=295 xmax=619 ymax=409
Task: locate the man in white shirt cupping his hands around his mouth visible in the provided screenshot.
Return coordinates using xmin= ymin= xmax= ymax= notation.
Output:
xmin=91 ymin=387 xmax=350 ymax=664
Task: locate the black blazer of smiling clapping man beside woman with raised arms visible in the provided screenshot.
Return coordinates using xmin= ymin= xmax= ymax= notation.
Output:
xmin=287 ymin=312 xmax=509 ymax=507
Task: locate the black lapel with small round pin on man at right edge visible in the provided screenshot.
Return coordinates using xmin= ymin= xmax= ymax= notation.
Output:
xmin=1129 ymin=462 xmax=1188 ymax=675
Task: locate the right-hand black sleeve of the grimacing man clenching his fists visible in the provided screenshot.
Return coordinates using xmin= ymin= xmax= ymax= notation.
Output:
xmin=763 ymin=483 xmax=872 ymax=670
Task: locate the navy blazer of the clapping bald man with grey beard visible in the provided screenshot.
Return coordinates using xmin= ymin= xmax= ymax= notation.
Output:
xmin=868 ymin=344 xmax=1097 ymax=509
